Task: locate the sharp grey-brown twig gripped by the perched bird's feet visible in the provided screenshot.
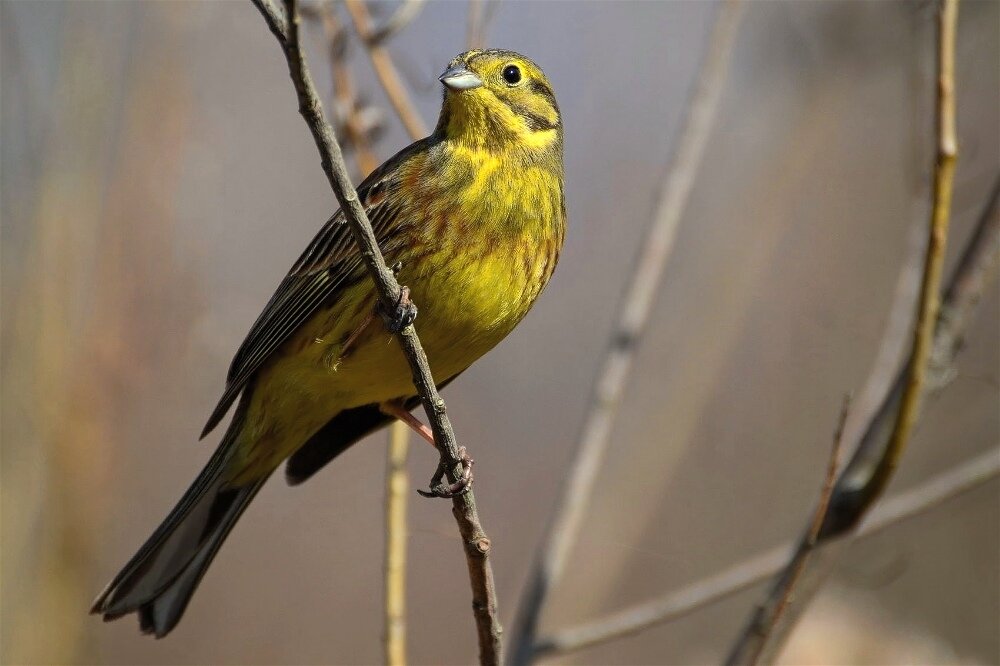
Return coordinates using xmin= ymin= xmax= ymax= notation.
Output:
xmin=253 ymin=0 xmax=501 ymax=664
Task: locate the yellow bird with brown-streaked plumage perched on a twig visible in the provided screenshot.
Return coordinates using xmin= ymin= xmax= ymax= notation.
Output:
xmin=91 ymin=49 xmax=566 ymax=638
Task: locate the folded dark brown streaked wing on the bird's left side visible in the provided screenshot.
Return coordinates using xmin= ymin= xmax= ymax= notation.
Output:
xmin=201 ymin=142 xmax=420 ymax=437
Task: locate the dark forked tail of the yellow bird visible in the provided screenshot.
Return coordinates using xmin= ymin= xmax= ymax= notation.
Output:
xmin=90 ymin=412 xmax=269 ymax=638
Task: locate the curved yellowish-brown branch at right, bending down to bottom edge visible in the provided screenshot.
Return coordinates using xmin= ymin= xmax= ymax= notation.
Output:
xmin=726 ymin=0 xmax=958 ymax=664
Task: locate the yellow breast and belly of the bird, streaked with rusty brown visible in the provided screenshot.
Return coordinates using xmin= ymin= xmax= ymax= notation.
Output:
xmin=229 ymin=144 xmax=565 ymax=478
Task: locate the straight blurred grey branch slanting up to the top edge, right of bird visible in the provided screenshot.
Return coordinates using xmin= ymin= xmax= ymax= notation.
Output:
xmin=508 ymin=0 xmax=742 ymax=664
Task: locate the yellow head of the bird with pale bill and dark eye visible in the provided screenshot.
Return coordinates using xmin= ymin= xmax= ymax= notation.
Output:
xmin=437 ymin=49 xmax=562 ymax=152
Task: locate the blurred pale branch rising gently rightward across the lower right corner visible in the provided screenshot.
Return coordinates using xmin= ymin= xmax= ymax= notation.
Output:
xmin=533 ymin=449 xmax=1000 ymax=659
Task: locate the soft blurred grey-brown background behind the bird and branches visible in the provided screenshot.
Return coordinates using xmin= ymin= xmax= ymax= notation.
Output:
xmin=0 ymin=0 xmax=1000 ymax=664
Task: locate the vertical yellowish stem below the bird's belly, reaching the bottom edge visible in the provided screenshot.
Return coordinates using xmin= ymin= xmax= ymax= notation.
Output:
xmin=385 ymin=421 xmax=410 ymax=666
